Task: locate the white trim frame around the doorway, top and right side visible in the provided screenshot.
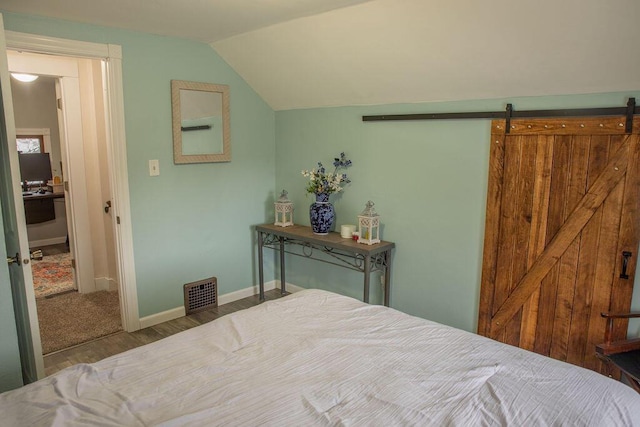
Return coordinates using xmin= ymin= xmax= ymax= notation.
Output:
xmin=5 ymin=31 xmax=140 ymax=332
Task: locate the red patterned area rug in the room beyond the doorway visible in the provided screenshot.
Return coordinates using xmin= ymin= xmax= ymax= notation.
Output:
xmin=31 ymin=252 xmax=74 ymax=298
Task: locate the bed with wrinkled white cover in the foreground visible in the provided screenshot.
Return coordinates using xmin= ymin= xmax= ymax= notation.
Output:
xmin=0 ymin=290 xmax=640 ymax=426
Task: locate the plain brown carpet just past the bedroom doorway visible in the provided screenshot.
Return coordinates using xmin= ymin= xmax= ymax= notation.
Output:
xmin=37 ymin=291 xmax=122 ymax=354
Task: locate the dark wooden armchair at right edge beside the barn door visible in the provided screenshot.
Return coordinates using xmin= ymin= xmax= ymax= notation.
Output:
xmin=596 ymin=313 xmax=640 ymax=393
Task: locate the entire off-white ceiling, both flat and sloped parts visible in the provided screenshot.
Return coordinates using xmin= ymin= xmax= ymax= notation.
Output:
xmin=0 ymin=0 xmax=640 ymax=110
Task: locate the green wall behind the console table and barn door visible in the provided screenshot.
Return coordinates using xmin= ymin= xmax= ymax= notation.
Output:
xmin=276 ymin=91 xmax=640 ymax=331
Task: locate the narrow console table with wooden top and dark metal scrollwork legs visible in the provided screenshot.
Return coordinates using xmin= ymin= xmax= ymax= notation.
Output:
xmin=256 ymin=224 xmax=395 ymax=307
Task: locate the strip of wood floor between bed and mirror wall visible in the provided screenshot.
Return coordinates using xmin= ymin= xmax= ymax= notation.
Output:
xmin=44 ymin=289 xmax=288 ymax=376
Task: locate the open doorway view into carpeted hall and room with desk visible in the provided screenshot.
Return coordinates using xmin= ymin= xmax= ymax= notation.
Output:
xmin=7 ymin=55 xmax=122 ymax=354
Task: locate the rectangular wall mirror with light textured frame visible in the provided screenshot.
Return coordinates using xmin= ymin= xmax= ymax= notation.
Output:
xmin=171 ymin=80 xmax=231 ymax=164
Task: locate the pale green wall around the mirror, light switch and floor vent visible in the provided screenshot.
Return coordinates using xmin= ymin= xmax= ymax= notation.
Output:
xmin=3 ymin=12 xmax=275 ymax=317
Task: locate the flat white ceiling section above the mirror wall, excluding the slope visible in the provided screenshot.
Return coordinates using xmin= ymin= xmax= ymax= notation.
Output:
xmin=0 ymin=0 xmax=376 ymax=43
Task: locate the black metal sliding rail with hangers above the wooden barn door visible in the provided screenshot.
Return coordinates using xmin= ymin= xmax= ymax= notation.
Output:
xmin=362 ymin=98 xmax=640 ymax=133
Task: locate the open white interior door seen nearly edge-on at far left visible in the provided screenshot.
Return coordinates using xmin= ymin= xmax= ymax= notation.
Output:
xmin=0 ymin=15 xmax=44 ymax=383
